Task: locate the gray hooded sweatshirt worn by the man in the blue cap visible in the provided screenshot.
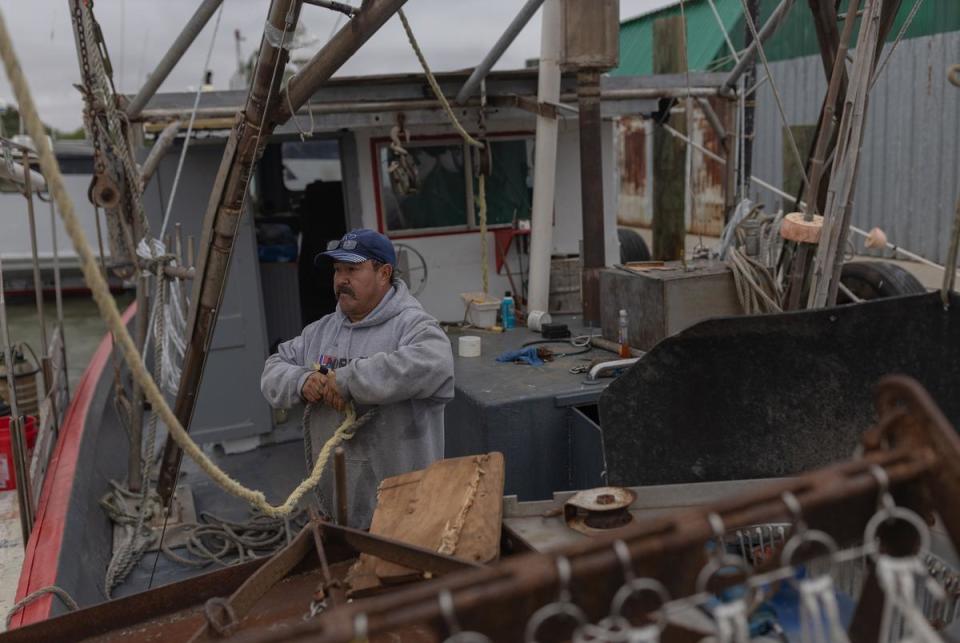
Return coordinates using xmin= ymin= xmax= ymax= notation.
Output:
xmin=260 ymin=281 xmax=453 ymax=528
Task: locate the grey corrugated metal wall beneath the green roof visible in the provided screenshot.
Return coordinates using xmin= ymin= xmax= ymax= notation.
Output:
xmin=753 ymin=32 xmax=960 ymax=262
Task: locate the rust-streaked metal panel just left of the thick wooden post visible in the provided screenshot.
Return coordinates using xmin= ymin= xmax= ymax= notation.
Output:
xmin=617 ymin=116 xmax=653 ymax=228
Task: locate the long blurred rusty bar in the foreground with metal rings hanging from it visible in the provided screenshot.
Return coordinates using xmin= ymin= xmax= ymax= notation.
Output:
xmin=284 ymin=378 xmax=960 ymax=641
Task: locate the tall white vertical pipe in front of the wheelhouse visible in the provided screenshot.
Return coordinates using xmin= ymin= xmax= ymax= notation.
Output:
xmin=527 ymin=0 xmax=563 ymax=311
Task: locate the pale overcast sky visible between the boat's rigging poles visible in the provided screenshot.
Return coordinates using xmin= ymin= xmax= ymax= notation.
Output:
xmin=0 ymin=0 xmax=670 ymax=130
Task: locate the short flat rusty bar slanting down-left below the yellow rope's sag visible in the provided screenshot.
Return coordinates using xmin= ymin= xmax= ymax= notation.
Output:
xmin=184 ymin=525 xmax=313 ymax=643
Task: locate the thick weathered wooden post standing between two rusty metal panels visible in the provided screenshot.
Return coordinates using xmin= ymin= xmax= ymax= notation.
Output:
xmin=653 ymin=16 xmax=687 ymax=261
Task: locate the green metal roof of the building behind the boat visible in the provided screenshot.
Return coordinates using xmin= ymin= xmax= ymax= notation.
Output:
xmin=610 ymin=0 xmax=960 ymax=76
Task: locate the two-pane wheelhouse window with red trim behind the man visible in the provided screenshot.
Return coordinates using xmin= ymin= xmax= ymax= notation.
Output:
xmin=374 ymin=137 xmax=533 ymax=236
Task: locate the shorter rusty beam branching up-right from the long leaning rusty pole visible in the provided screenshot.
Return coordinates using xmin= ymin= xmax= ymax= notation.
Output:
xmin=268 ymin=0 xmax=406 ymax=126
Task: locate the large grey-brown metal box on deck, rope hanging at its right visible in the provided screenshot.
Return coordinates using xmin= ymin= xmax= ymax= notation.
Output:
xmin=600 ymin=261 xmax=743 ymax=350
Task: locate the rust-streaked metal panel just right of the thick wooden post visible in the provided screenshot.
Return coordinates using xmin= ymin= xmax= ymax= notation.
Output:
xmin=686 ymin=98 xmax=728 ymax=237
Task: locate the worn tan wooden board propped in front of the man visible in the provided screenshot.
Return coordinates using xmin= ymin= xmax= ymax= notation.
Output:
xmin=348 ymin=453 xmax=504 ymax=596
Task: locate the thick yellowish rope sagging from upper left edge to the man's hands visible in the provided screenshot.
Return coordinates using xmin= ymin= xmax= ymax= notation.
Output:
xmin=0 ymin=11 xmax=356 ymax=516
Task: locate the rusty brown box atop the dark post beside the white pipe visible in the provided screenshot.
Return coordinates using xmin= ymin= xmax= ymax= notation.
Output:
xmin=560 ymin=0 xmax=620 ymax=70
